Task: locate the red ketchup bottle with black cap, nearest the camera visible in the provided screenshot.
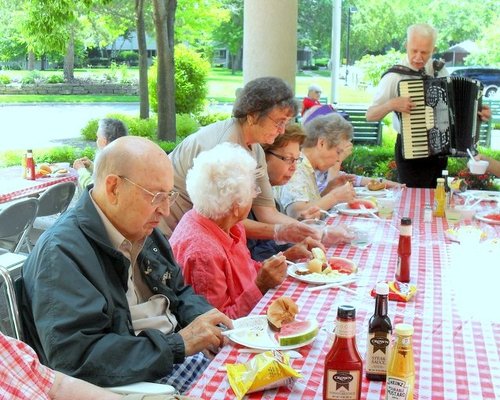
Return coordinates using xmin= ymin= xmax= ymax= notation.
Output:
xmin=323 ymin=305 xmax=363 ymax=400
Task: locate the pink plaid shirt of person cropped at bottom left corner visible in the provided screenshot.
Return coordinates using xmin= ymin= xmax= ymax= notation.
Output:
xmin=0 ymin=332 xmax=55 ymax=400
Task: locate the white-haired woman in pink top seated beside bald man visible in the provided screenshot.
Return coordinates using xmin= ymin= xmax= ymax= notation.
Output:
xmin=169 ymin=142 xmax=286 ymax=318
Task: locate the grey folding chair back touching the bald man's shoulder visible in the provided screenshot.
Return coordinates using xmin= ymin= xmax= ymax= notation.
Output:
xmin=32 ymin=182 xmax=76 ymax=236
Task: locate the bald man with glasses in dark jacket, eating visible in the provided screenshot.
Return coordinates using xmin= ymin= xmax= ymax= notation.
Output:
xmin=23 ymin=136 xmax=232 ymax=391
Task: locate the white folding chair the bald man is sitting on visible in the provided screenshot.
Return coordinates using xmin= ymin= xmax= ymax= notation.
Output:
xmin=0 ymin=265 xmax=176 ymax=395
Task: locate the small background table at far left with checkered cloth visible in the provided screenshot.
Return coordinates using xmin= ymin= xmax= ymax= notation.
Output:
xmin=0 ymin=166 xmax=78 ymax=204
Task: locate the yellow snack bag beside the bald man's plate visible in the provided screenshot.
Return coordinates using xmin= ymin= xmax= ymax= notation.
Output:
xmin=226 ymin=350 xmax=302 ymax=400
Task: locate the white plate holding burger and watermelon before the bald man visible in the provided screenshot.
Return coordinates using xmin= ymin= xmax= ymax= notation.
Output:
xmin=228 ymin=315 xmax=316 ymax=350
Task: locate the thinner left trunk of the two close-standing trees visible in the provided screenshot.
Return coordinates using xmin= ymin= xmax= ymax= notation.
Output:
xmin=135 ymin=0 xmax=149 ymax=119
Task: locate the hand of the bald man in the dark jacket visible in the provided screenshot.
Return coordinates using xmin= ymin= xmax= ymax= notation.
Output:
xmin=179 ymin=308 xmax=233 ymax=356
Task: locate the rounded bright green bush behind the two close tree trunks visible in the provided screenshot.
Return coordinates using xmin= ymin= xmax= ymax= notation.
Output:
xmin=148 ymin=45 xmax=210 ymax=114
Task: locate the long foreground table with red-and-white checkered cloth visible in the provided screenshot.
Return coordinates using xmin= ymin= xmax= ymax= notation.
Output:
xmin=189 ymin=189 xmax=500 ymax=400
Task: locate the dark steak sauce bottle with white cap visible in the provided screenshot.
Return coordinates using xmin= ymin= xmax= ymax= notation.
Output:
xmin=365 ymin=282 xmax=392 ymax=381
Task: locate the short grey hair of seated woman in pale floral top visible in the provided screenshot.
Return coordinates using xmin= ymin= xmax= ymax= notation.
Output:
xmin=303 ymin=113 xmax=352 ymax=148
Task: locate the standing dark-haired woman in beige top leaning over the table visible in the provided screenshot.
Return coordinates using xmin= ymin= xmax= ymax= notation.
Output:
xmin=162 ymin=77 xmax=318 ymax=247
